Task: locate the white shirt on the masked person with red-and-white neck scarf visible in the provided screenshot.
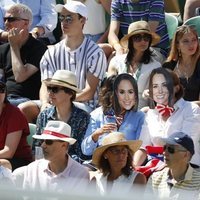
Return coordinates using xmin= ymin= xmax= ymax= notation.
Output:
xmin=140 ymin=98 xmax=200 ymax=165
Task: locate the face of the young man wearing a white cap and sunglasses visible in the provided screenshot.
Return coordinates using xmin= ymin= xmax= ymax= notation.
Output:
xmin=59 ymin=9 xmax=85 ymax=36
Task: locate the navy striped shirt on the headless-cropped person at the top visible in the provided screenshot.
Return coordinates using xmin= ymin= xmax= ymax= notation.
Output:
xmin=111 ymin=0 xmax=169 ymax=56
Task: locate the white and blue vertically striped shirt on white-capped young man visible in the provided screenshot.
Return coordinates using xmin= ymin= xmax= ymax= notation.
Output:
xmin=40 ymin=37 xmax=107 ymax=109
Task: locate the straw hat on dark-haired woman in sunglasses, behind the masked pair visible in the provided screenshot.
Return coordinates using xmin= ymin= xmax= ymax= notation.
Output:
xmin=120 ymin=21 xmax=160 ymax=48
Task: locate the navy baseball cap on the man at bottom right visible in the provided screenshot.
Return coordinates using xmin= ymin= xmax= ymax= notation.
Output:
xmin=163 ymin=132 xmax=194 ymax=155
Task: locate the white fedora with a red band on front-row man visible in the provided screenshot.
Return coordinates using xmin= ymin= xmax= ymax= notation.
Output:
xmin=33 ymin=121 xmax=76 ymax=144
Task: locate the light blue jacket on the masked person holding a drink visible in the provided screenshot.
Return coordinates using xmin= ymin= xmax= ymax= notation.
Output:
xmin=81 ymin=107 xmax=144 ymax=156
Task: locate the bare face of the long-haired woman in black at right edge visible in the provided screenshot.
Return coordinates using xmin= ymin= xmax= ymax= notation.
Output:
xmin=178 ymin=32 xmax=198 ymax=56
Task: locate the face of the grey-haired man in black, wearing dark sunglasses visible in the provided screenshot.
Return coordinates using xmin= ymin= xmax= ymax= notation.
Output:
xmin=4 ymin=12 xmax=29 ymax=31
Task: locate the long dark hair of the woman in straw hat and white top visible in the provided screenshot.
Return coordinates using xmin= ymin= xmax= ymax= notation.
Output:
xmin=125 ymin=35 xmax=152 ymax=66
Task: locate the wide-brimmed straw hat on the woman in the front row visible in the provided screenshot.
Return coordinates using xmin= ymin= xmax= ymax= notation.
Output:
xmin=92 ymin=132 xmax=142 ymax=165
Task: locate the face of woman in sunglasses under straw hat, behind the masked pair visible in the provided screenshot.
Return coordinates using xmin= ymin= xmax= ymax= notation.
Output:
xmin=132 ymin=33 xmax=151 ymax=52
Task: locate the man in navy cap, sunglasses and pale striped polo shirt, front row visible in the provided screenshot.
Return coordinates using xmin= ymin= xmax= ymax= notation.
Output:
xmin=147 ymin=132 xmax=200 ymax=199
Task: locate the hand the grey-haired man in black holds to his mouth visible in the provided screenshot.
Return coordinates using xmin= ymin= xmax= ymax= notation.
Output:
xmin=8 ymin=28 xmax=25 ymax=48
